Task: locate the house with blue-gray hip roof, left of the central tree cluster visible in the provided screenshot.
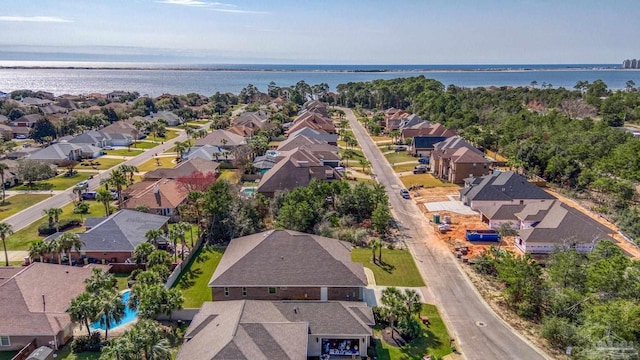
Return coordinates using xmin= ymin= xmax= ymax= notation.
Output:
xmin=45 ymin=209 xmax=169 ymax=263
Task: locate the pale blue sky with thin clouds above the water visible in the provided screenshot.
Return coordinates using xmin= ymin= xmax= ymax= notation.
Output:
xmin=0 ymin=0 xmax=640 ymax=65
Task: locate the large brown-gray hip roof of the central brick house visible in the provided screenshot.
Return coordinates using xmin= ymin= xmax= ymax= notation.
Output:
xmin=209 ymin=230 xmax=367 ymax=287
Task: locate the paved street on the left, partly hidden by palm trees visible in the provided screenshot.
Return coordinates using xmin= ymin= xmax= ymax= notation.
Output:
xmin=3 ymin=133 xmax=187 ymax=231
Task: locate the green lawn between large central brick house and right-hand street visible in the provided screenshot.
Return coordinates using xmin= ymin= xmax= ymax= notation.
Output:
xmin=351 ymin=248 xmax=424 ymax=287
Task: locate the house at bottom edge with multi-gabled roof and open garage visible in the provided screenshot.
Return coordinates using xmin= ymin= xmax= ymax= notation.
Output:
xmin=176 ymin=300 xmax=375 ymax=360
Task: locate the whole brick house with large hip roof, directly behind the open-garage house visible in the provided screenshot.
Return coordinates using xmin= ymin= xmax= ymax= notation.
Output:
xmin=209 ymin=230 xmax=367 ymax=301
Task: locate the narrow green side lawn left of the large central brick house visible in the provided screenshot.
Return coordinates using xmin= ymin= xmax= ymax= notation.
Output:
xmin=173 ymin=246 xmax=224 ymax=308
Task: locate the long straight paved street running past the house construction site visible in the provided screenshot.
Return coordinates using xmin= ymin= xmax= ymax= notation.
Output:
xmin=343 ymin=108 xmax=547 ymax=360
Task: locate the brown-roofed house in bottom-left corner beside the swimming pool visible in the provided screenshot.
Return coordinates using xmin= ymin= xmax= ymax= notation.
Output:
xmin=0 ymin=262 xmax=108 ymax=351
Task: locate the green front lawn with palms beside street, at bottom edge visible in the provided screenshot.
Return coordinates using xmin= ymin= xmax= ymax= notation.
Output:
xmin=374 ymin=304 xmax=455 ymax=360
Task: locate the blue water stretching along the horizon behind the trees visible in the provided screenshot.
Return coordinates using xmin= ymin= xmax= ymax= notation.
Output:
xmin=0 ymin=61 xmax=640 ymax=96
